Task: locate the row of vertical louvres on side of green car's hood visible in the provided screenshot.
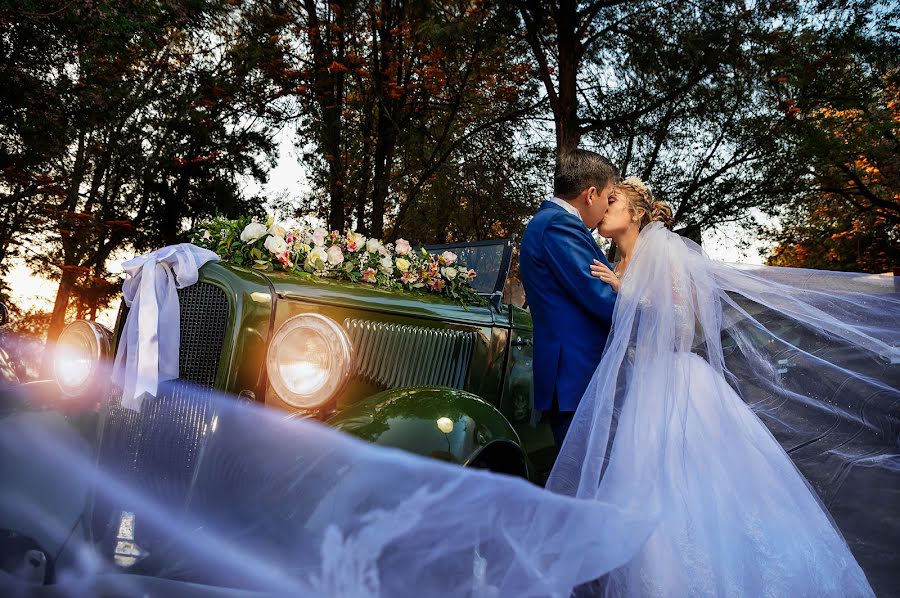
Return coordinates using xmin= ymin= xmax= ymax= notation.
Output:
xmin=344 ymin=319 xmax=476 ymax=388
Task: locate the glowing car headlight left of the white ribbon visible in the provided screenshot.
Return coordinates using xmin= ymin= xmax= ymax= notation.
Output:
xmin=53 ymin=320 xmax=111 ymax=396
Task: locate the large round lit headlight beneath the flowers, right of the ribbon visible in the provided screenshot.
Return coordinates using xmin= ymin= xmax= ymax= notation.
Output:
xmin=266 ymin=314 xmax=353 ymax=409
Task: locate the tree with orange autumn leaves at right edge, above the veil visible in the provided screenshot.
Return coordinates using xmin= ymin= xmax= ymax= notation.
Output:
xmin=768 ymin=4 xmax=900 ymax=272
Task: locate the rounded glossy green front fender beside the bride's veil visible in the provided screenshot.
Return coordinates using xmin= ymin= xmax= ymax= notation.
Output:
xmin=327 ymin=387 xmax=531 ymax=477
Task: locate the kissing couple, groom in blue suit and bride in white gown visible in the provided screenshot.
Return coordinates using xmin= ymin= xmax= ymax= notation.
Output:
xmin=519 ymin=150 xmax=873 ymax=596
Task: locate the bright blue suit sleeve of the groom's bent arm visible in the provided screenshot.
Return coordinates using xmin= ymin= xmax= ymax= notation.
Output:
xmin=544 ymin=218 xmax=616 ymax=324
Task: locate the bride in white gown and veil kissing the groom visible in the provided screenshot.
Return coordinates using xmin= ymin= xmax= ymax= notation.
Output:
xmin=547 ymin=177 xmax=873 ymax=596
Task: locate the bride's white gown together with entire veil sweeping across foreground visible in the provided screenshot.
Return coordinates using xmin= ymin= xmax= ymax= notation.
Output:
xmin=0 ymin=223 xmax=900 ymax=598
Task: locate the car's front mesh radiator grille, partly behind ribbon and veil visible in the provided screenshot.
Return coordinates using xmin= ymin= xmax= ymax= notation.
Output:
xmin=92 ymin=282 xmax=228 ymax=564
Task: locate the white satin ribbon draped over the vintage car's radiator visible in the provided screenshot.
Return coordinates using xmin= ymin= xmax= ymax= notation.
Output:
xmin=112 ymin=243 xmax=219 ymax=411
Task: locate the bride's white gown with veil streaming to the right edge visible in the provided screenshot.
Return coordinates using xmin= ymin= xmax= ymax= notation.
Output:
xmin=547 ymin=223 xmax=900 ymax=596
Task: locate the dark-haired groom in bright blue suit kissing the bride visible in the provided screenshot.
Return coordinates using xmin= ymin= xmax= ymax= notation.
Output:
xmin=519 ymin=150 xmax=618 ymax=449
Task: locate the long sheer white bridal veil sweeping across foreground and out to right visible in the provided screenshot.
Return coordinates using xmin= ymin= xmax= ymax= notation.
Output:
xmin=0 ymin=223 xmax=900 ymax=596
